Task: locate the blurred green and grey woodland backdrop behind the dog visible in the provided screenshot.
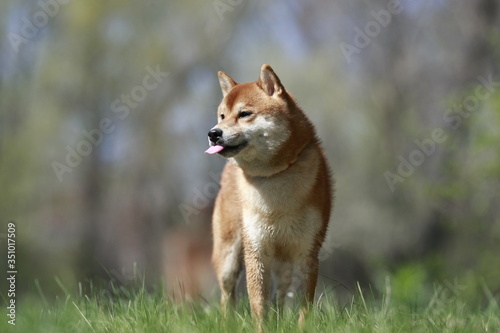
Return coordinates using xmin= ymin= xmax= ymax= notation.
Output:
xmin=0 ymin=0 xmax=500 ymax=301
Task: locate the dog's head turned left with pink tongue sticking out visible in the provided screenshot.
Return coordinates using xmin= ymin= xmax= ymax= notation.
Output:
xmin=206 ymin=65 xmax=295 ymax=161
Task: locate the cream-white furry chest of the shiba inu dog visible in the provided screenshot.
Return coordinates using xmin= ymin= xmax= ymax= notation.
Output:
xmin=242 ymin=173 xmax=322 ymax=260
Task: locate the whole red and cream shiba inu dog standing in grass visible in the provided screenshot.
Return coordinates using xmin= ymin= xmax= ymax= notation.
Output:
xmin=206 ymin=65 xmax=333 ymax=328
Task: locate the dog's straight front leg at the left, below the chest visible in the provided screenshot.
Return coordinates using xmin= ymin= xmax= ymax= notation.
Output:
xmin=244 ymin=245 xmax=271 ymax=331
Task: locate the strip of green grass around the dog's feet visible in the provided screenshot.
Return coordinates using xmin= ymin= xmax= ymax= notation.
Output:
xmin=0 ymin=280 xmax=500 ymax=333
